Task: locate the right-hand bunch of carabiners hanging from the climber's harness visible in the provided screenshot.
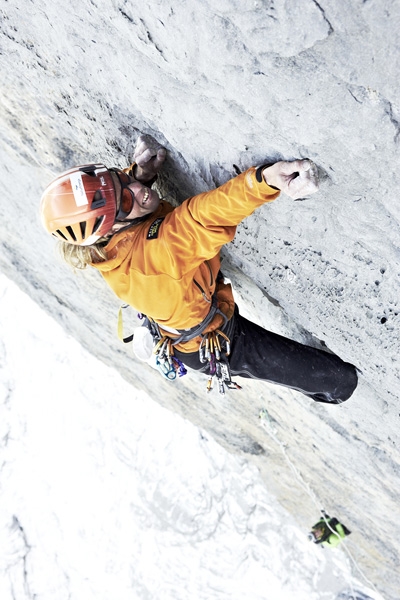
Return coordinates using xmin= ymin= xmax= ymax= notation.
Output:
xmin=199 ymin=329 xmax=242 ymax=394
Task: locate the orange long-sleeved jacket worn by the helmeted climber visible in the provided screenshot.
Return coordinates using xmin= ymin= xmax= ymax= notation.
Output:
xmin=93 ymin=167 xmax=279 ymax=352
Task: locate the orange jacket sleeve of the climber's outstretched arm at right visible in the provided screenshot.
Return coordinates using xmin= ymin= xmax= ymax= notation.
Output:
xmin=164 ymin=167 xmax=280 ymax=266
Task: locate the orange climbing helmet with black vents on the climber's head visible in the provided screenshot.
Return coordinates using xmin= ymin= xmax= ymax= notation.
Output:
xmin=40 ymin=164 xmax=117 ymax=246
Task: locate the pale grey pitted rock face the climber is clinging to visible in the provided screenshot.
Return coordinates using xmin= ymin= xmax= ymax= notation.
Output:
xmin=0 ymin=0 xmax=400 ymax=599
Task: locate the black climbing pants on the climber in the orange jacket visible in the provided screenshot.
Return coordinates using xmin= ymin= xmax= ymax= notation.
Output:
xmin=175 ymin=308 xmax=357 ymax=404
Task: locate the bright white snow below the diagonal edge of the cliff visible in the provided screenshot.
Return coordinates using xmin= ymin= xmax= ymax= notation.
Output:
xmin=0 ymin=275 xmax=382 ymax=600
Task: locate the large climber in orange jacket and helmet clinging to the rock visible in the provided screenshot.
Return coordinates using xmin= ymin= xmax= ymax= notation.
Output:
xmin=41 ymin=135 xmax=357 ymax=404
